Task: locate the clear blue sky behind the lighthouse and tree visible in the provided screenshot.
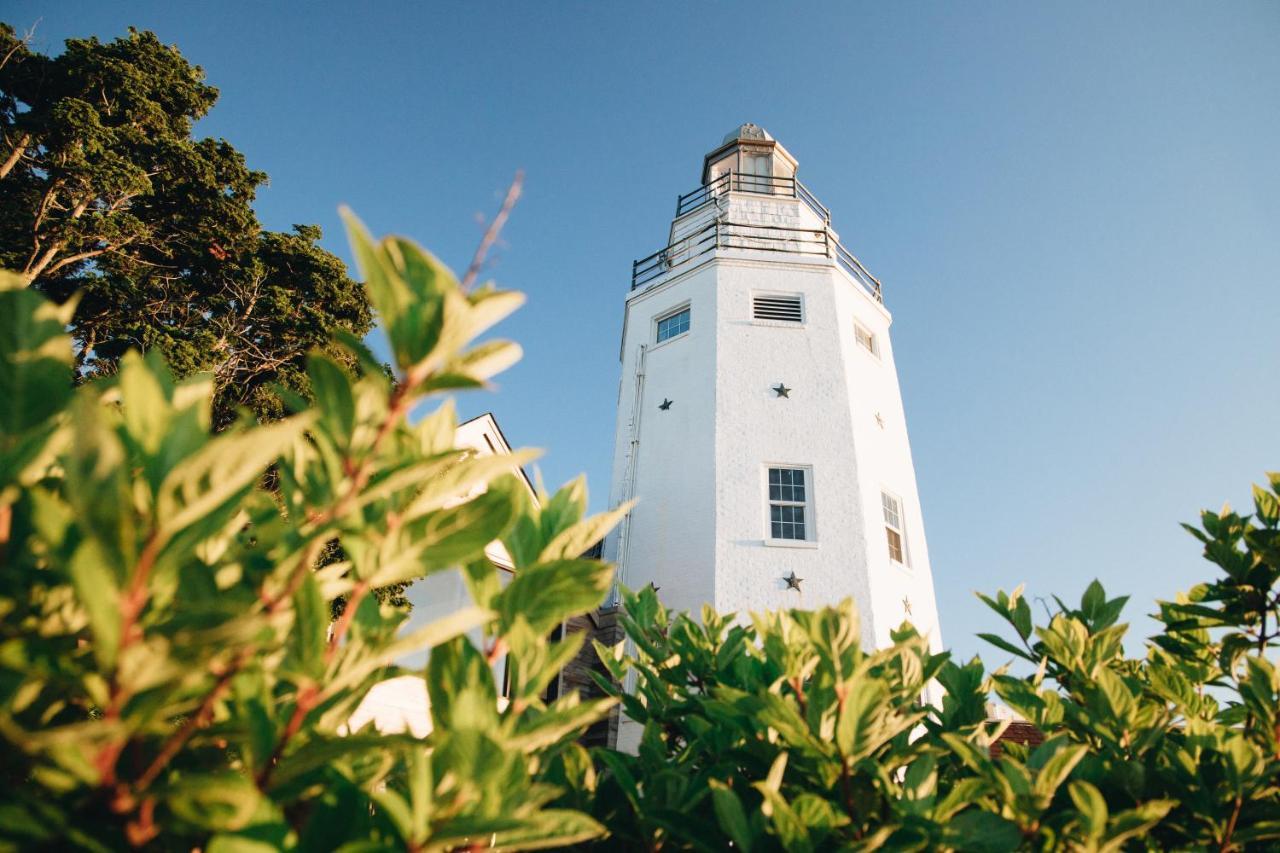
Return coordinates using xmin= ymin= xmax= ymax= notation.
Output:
xmin=12 ymin=0 xmax=1280 ymax=663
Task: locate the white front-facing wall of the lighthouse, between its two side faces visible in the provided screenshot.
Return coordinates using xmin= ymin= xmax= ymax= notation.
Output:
xmin=716 ymin=257 xmax=873 ymax=642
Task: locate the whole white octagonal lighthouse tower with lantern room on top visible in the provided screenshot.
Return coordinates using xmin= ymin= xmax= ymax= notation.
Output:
xmin=604 ymin=124 xmax=941 ymax=648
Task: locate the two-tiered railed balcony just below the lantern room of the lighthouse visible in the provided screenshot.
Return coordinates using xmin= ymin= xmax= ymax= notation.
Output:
xmin=631 ymin=172 xmax=884 ymax=302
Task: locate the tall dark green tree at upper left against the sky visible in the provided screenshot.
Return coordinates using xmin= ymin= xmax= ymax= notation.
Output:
xmin=0 ymin=24 xmax=371 ymax=428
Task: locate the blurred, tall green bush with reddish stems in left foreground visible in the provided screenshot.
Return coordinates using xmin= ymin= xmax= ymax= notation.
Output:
xmin=0 ymin=211 xmax=617 ymax=852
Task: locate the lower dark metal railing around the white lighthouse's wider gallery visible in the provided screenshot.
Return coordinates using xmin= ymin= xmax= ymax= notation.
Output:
xmin=631 ymin=219 xmax=884 ymax=302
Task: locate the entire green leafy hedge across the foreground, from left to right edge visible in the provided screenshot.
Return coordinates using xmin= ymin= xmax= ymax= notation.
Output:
xmin=0 ymin=201 xmax=1280 ymax=853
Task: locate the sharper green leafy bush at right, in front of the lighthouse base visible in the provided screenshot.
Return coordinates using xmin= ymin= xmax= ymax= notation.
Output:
xmin=581 ymin=474 xmax=1280 ymax=852
